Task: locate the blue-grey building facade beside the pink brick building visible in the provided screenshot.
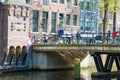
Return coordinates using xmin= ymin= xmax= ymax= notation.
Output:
xmin=80 ymin=0 xmax=98 ymax=32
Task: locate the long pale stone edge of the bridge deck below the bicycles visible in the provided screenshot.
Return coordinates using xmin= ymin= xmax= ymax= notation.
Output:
xmin=33 ymin=46 xmax=120 ymax=53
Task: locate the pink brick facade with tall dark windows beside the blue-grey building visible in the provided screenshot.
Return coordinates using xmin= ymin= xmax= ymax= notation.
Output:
xmin=30 ymin=0 xmax=79 ymax=42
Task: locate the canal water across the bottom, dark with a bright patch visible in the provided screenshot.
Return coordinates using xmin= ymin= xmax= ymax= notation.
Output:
xmin=0 ymin=68 xmax=120 ymax=80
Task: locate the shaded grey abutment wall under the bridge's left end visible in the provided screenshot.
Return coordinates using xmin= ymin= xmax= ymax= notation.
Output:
xmin=31 ymin=52 xmax=73 ymax=69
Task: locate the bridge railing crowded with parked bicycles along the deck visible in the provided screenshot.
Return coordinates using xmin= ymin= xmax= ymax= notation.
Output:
xmin=32 ymin=33 xmax=120 ymax=44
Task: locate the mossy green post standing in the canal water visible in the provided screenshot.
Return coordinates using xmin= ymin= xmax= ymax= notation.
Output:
xmin=74 ymin=58 xmax=80 ymax=80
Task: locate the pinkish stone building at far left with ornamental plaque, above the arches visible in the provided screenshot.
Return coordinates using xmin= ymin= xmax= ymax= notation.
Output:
xmin=0 ymin=0 xmax=30 ymax=52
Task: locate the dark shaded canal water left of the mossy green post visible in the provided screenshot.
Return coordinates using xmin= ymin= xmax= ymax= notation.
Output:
xmin=0 ymin=71 xmax=74 ymax=80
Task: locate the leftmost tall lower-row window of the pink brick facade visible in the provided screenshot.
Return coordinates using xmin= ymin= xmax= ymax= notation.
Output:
xmin=32 ymin=10 xmax=39 ymax=32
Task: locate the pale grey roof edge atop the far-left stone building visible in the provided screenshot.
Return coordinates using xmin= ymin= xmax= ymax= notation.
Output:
xmin=2 ymin=0 xmax=30 ymax=7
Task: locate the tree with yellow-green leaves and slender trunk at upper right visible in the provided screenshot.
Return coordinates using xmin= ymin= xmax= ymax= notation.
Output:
xmin=99 ymin=0 xmax=120 ymax=43
